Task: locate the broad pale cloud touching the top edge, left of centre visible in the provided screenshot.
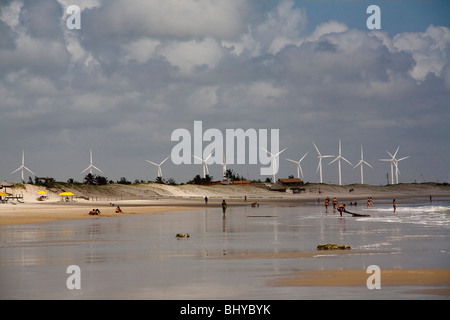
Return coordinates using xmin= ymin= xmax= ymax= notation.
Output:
xmin=96 ymin=0 xmax=248 ymax=39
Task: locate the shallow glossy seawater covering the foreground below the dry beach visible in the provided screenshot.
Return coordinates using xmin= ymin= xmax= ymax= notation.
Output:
xmin=0 ymin=199 xmax=450 ymax=300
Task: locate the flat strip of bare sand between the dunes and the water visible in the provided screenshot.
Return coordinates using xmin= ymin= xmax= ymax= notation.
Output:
xmin=0 ymin=194 xmax=450 ymax=226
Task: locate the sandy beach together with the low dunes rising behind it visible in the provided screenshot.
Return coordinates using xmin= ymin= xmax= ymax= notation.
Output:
xmin=0 ymin=183 xmax=450 ymax=225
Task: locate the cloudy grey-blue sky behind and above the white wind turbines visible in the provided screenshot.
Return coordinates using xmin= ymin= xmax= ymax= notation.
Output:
xmin=0 ymin=0 xmax=450 ymax=185
